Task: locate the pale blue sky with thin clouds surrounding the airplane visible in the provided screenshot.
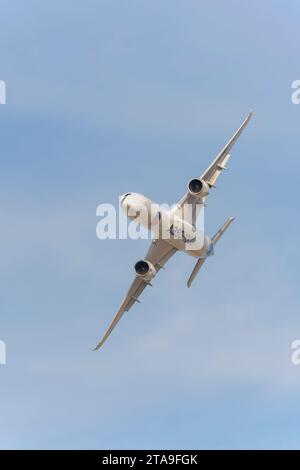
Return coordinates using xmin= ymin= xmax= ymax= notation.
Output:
xmin=0 ymin=0 xmax=300 ymax=449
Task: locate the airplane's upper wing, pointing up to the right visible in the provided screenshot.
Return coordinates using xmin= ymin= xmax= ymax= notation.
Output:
xmin=177 ymin=111 xmax=252 ymax=209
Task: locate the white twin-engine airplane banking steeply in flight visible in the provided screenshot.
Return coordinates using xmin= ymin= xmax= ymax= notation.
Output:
xmin=93 ymin=111 xmax=253 ymax=351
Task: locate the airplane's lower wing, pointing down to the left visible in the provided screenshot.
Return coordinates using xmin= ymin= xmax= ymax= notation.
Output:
xmin=94 ymin=240 xmax=177 ymax=351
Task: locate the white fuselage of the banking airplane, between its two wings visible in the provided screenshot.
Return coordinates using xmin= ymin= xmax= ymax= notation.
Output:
xmin=120 ymin=193 xmax=211 ymax=258
